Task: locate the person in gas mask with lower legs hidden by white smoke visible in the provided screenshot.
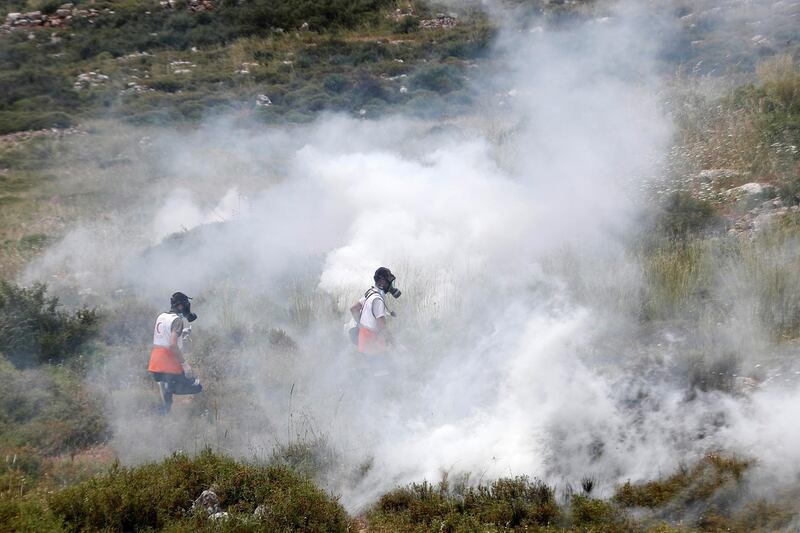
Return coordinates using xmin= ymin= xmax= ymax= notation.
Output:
xmin=350 ymin=267 xmax=401 ymax=355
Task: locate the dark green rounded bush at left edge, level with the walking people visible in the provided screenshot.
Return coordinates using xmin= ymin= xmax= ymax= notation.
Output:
xmin=0 ymin=281 xmax=100 ymax=367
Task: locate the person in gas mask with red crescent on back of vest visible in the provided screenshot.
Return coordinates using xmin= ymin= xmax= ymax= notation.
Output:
xmin=147 ymin=292 xmax=203 ymax=413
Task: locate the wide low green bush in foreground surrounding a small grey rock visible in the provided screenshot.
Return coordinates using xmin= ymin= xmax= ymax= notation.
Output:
xmin=49 ymin=450 xmax=347 ymax=532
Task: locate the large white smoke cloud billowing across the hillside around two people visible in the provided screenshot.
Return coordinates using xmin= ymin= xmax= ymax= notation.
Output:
xmin=21 ymin=0 xmax=800 ymax=509
